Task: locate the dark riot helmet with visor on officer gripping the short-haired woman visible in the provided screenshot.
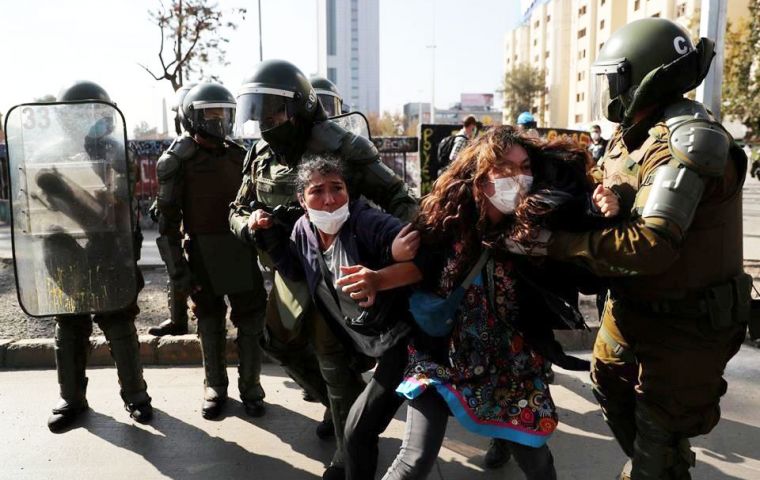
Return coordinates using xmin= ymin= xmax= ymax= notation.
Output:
xmin=235 ymin=60 xmax=326 ymax=144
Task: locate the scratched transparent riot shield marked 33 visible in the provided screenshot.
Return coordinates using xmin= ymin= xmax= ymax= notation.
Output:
xmin=5 ymin=101 xmax=137 ymax=316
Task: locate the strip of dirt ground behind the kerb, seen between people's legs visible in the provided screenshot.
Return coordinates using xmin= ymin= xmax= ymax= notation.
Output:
xmin=0 ymin=259 xmax=760 ymax=339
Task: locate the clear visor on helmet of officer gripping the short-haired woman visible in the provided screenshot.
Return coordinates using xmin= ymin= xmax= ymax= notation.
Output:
xmin=235 ymin=88 xmax=296 ymax=138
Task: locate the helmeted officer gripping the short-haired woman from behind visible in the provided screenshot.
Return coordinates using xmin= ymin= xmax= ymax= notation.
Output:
xmin=230 ymin=60 xmax=417 ymax=478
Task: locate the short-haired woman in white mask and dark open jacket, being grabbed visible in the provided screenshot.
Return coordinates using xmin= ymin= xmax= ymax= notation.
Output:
xmin=255 ymin=156 xmax=419 ymax=479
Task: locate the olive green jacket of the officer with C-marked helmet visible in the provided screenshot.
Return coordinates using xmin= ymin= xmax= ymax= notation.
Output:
xmin=549 ymin=101 xmax=746 ymax=300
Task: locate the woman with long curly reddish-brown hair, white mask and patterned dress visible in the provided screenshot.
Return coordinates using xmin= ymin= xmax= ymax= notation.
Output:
xmin=384 ymin=127 xmax=616 ymax=480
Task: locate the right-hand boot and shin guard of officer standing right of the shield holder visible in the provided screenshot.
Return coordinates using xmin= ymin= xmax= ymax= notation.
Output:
xmin=235 ymin=323 xmax=265 ymax=417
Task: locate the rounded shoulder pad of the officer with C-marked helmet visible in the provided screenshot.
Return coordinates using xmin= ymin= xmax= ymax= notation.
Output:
xmin=666 ymin=108 xmax=732 ymax=177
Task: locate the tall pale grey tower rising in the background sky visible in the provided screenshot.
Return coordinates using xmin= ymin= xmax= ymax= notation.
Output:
xmin=317 ymin=0 xmax=380 ymax=114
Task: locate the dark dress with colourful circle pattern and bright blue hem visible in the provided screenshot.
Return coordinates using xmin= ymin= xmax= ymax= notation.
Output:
xmin=396 ymin=249 xmax=557 ymax=447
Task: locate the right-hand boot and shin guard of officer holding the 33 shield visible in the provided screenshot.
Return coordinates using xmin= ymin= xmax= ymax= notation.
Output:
xmin=101 ymin=312 xmax=153 ymax=423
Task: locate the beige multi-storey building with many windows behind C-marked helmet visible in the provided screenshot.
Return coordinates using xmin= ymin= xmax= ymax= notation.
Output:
xmin=504 ymin=0 xmax=748 ymax=129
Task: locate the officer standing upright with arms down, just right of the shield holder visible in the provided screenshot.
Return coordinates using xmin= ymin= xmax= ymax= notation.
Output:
xmin=156 ymin=83 xmax=266 ymax=419
